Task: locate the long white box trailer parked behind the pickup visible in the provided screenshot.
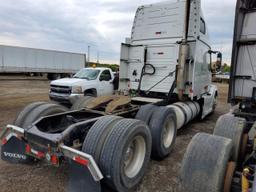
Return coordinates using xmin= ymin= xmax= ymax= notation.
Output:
xmin=0 ymin=45 xmax=86 ymax=80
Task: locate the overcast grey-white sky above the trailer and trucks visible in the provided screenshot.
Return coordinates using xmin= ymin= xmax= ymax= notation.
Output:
xmin=0 ymin=0 xmax=235 ymax=63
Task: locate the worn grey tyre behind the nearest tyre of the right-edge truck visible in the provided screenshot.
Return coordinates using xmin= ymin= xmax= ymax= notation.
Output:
xmin=213 ymin=114 xmax=246 ymax=161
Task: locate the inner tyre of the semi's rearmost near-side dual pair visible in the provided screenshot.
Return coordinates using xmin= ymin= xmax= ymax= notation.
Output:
xmin=82 ymin=115 xmax=122 ymax=163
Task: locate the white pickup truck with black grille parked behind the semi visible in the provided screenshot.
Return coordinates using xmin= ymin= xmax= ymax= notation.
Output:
xmin=49 ymin=68 xmax=114 ymax=104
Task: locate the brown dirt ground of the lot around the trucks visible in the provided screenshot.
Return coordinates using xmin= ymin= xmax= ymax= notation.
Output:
xmin=0 ymin=76 xmax=229 ymax=192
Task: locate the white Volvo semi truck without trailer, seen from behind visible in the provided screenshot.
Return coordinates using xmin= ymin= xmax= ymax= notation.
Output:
xmin=0 ymin=0 xmax=221 ymax=192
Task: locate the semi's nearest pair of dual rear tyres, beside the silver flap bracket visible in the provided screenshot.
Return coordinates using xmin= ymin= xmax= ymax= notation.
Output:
xmin=82 ymin=116 xmax=152 ymax=192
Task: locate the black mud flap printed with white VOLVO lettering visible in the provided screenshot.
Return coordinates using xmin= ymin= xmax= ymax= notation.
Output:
xmin=1 ymin=136 xmax=33 ymax=163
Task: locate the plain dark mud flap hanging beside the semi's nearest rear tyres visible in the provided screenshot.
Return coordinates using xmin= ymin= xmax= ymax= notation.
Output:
xmin=67 ymin=160 xmax=101 ymax=192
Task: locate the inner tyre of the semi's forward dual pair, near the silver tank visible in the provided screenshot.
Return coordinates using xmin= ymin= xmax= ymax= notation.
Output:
xmin=135 ymin=104 xmax=157 ymax=125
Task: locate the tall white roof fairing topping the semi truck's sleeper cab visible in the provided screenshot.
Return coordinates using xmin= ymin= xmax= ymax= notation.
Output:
xmin=131 ymin=0 xmax=209 ymax=44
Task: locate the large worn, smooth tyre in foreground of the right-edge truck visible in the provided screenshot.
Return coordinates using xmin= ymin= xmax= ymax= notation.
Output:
xmin=180 ymin=133 xmax=232 ymax=192
